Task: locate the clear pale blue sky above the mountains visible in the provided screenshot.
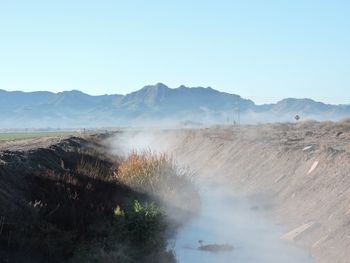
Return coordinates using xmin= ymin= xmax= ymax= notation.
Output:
xmin=0 ymin=0 xmax=350 ymax=103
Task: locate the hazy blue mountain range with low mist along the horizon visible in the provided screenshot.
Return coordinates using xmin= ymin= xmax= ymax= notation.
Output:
xmin=0 ymin=83 xmax=350 ymax=129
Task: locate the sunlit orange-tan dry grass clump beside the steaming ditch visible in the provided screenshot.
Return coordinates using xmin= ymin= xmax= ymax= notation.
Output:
xmin=115 ymin=151 xmax=200 ymax=226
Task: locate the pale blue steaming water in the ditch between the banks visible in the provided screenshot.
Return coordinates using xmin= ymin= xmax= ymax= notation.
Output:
xmin=173 ymin=185 xmax=312 ymax=263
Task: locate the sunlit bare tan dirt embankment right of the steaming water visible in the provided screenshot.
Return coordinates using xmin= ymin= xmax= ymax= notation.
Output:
xmin=157 ymin=122 xmax=350 ymax=263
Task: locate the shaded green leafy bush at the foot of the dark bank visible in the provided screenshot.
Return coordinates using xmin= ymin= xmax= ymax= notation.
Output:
xmin=71 ymin=200 xmax=175 ymax=263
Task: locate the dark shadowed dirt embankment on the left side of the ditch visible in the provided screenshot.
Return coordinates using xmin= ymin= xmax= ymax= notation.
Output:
xmin=0 ymin=136 xmax=145 ymax=262
